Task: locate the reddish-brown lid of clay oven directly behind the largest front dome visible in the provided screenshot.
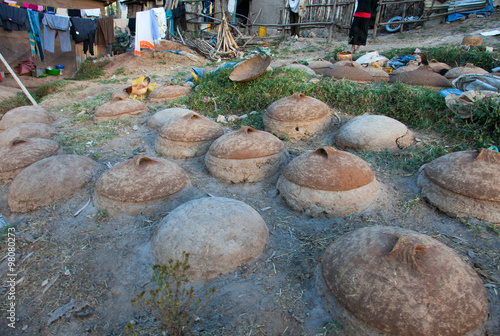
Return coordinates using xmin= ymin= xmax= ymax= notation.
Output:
xmin=283 ymin=147 xmax=375 ymax=191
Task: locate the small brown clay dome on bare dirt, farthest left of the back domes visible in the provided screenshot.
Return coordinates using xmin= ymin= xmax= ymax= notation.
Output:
xmin=94 ymin=99 xmax=148 ymax=124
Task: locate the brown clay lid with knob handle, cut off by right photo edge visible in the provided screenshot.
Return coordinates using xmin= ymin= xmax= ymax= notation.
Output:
xmin=424 ymin=148 xmax=500 ymax=202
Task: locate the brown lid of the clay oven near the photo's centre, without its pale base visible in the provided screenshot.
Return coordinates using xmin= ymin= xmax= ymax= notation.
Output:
xmin=209 ymin=126 xmax=285 ymax=160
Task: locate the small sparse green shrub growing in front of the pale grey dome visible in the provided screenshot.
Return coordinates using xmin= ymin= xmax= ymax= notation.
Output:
xmin=125 ymin=252 xmax=215 ymax=336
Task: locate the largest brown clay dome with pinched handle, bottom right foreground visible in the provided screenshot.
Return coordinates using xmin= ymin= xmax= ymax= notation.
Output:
xmin=321 ymin=226 xmax=488 ymax=336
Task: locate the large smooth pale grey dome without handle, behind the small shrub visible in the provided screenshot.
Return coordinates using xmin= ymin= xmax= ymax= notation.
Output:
xmin=151 ymin=197 xmax=269 ymax=282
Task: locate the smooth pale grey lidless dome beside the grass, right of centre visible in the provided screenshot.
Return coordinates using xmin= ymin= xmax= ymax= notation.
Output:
xmin=335 ymin=115 xmax=413 ymax=151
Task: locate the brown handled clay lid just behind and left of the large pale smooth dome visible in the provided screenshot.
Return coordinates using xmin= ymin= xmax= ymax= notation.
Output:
xmin=96 ymin=155 xmax=189 ymax=202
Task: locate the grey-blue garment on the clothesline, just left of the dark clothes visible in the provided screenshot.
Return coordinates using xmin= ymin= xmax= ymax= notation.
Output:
xmin=42 ymin=14 xmax=71 ymax=52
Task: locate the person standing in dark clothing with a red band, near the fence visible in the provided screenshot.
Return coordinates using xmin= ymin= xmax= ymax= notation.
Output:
xmin=349 ymin=0 xmax=372 ymax=54
